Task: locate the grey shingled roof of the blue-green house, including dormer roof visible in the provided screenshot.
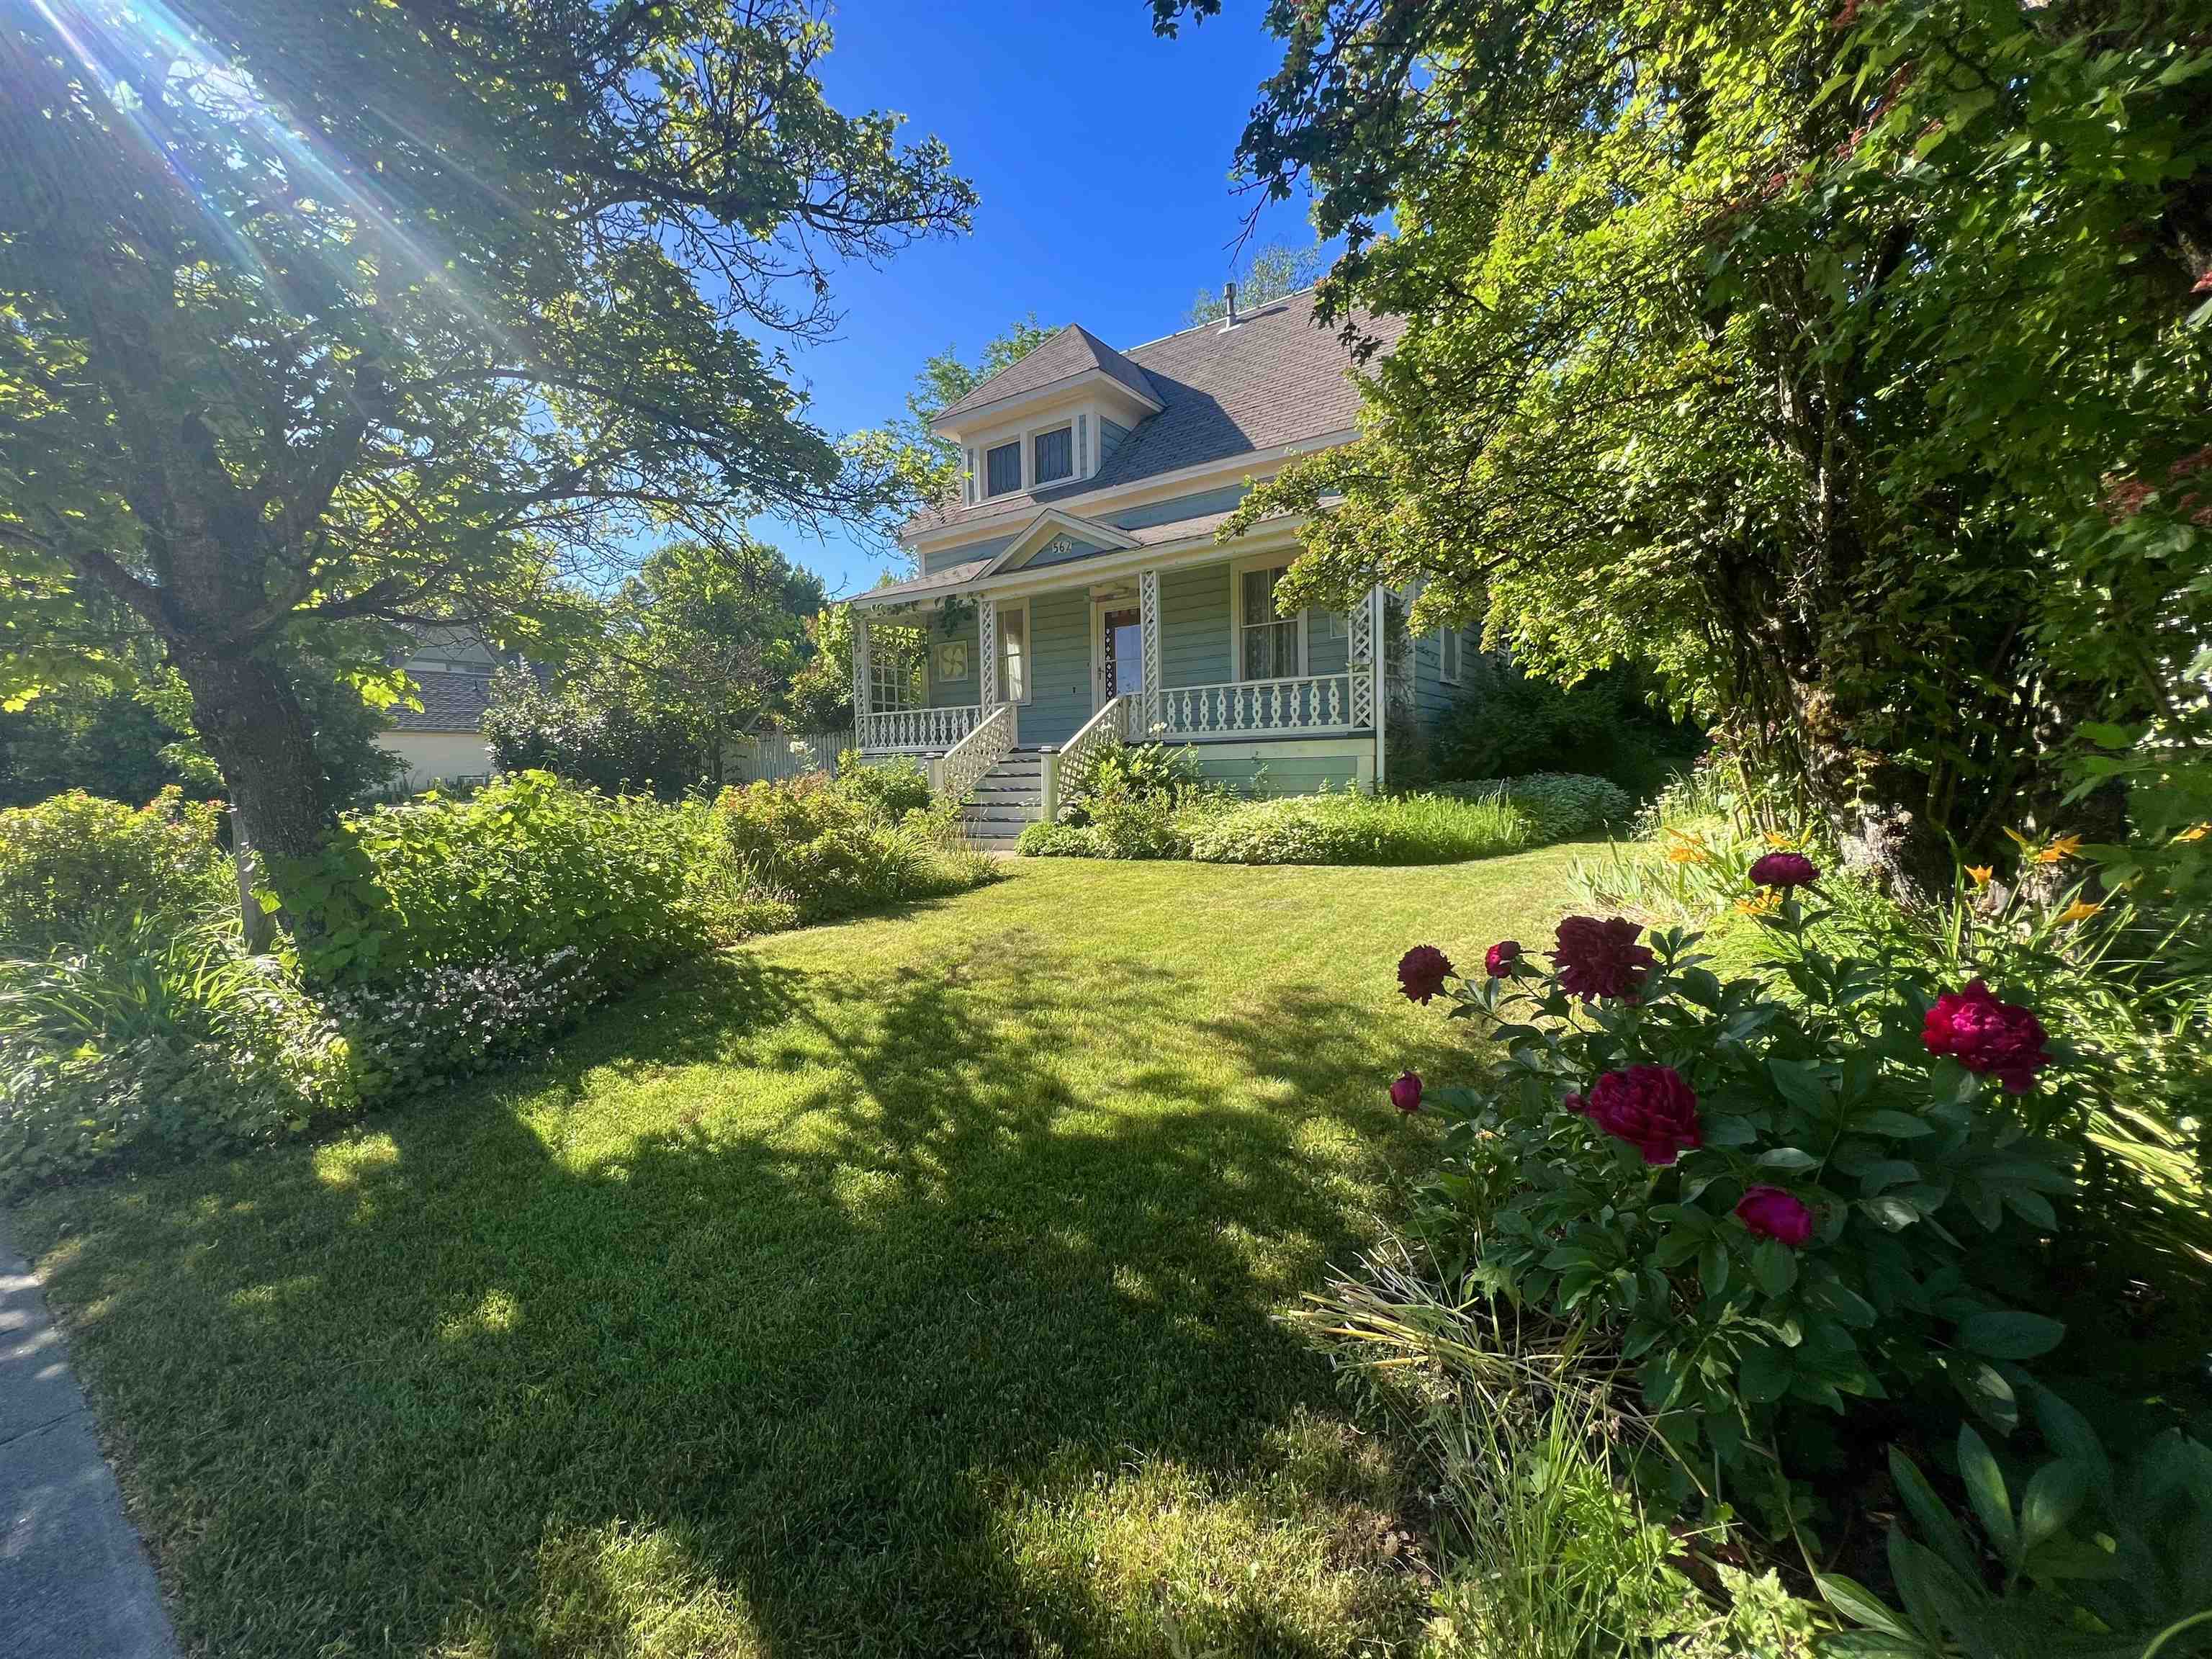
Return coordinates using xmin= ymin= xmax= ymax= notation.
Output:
xmin=904 ymin=289 xmax=1405 ymax=535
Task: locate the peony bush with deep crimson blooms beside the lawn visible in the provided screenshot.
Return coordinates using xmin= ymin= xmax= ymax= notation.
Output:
xmin=1401 ymin=869 xmax=2070 ymax=1502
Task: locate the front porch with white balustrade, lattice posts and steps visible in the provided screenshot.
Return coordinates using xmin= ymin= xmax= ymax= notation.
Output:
xmin=854 ymin=547 xmax=1382 ymax=838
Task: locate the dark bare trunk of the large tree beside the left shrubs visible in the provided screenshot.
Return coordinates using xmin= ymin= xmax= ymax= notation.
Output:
xmin=171 ymin=644 xmax=330 ymax=858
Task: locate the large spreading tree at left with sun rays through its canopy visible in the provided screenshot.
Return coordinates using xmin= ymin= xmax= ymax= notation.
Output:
xmin=0 ymin=0 xmax=974 ymax=871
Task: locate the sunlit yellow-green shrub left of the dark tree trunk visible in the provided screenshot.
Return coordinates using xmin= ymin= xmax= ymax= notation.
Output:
xmin=0 ymin=788 xmax=237 ymax=949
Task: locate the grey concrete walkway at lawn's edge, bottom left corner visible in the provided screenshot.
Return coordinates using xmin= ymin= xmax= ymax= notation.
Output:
xmin=0 ymin=1210 xmax=177 ymax=1659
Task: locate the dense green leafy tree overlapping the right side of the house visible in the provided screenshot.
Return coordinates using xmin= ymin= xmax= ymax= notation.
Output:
xmin=1155 ymin=0 xmax=2212 ymax=887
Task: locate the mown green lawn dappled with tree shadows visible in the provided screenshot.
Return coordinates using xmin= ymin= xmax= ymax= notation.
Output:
xmin=13 ymin=850 xmax=1570 ymax=1659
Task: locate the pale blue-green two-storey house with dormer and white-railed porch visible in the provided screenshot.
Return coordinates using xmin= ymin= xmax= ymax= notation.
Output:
xmin=854 ymin=292 xmax=1473 ymax=838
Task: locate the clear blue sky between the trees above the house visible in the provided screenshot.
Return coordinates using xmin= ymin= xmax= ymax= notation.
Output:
xmin=759 ymin=0 xmax=1312 ymax=593
